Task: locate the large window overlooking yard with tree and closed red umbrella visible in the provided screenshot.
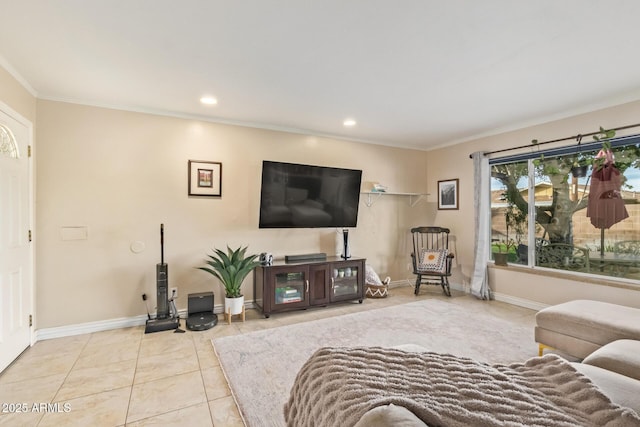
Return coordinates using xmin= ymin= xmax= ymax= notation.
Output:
xmin=490 ymin=135 xmax=640 ymax=280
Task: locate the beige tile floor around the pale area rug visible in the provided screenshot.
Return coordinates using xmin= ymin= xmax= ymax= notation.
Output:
xmin=0 ymin=286 xmax=530 ymax=427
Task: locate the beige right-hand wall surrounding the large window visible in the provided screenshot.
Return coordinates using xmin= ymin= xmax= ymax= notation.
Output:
xmin=427 ymin=102 xmax=640 ymax=307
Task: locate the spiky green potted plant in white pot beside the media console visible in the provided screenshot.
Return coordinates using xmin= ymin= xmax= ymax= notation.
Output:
xmin=198 ymin=246 xmax=260 ymax=315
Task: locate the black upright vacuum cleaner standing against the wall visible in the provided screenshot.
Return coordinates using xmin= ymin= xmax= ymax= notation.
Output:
xmin=142 ymin=224 xmax=183 ymax=334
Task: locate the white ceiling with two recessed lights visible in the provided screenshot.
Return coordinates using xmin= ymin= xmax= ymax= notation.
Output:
xmin=0 ymin=0 xmax=640 ymax=149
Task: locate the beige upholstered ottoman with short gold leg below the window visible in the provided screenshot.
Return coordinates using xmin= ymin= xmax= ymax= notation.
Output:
xmin=535 ymin=300 xmax=640 ymax=359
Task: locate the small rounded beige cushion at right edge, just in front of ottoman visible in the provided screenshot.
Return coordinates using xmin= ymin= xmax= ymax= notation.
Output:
xmin=582 ymin=340 xmax=640 ymax=380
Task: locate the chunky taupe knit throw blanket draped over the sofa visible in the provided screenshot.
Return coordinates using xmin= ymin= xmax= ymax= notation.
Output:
xmin=284 ymin=347 xmax=640 ymax=427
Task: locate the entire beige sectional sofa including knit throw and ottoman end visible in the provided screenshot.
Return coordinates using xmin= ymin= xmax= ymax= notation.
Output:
xmin=284 ymin=301 xmax=640 ymax=427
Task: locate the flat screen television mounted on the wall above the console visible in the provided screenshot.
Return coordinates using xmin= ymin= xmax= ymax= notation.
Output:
xmin=259 ymin=160 xmax=362 ymax=228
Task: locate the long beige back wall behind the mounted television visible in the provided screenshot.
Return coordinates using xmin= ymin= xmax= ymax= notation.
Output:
xmin=32 ymin=101 xmax=429 ymax=328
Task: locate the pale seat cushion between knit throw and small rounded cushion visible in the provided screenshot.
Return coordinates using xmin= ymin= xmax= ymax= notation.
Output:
xmin=571 ymin=362 xmax=640 ymax=414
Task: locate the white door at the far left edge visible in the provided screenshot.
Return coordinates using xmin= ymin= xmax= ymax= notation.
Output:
xmin=0 ymin=105 xmax=33 ymax=372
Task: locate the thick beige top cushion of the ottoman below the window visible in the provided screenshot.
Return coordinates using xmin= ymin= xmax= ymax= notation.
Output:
xmin=536 ymin=300 xmax=640 ymax=346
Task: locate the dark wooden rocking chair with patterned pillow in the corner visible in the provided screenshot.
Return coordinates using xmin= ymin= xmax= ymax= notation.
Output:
xmin=411 ymin=227 xmax=454 ymax=296
